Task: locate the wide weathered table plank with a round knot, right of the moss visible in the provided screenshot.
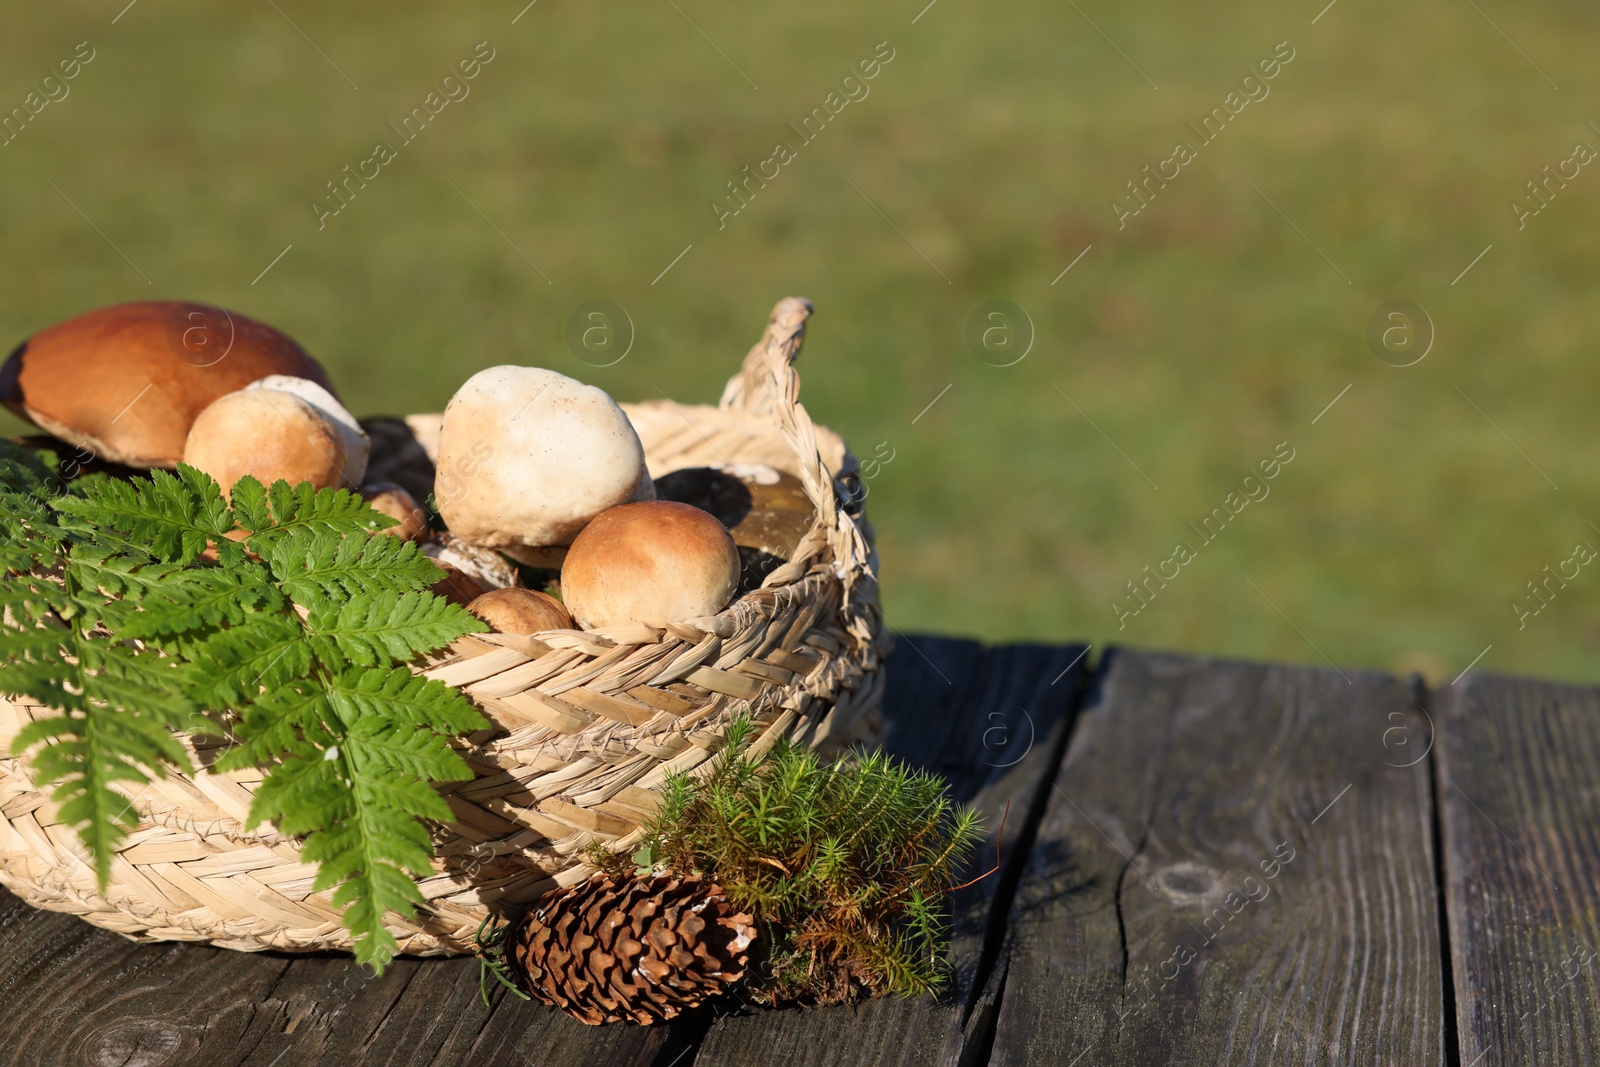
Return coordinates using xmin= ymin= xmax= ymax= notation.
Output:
xmin=989 ymin=653 xmax=1445 ymax=1067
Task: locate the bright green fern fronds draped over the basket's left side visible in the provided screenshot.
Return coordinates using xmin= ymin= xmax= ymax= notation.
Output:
xmin=0 ymin=445 xmax=488 ymax=966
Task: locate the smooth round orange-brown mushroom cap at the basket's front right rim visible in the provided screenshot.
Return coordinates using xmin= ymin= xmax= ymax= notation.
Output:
xmin=562 ymin=501 xmax=739 ymax=630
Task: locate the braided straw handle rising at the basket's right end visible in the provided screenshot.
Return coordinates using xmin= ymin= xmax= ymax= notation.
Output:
xmin=722 ymin=296 xmax=872 ymax=597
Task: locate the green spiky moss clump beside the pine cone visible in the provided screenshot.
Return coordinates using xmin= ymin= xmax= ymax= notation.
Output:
xmin=594 ymin=717 xmax=982 ymax=1003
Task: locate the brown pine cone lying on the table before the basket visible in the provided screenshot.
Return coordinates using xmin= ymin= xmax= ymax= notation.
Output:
xmin=507 ymin=875 xmax=755 ymax=1025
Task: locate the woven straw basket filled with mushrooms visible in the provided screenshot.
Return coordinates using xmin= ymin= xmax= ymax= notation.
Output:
xmin=0 ymin=298 xmax=886 ymax=955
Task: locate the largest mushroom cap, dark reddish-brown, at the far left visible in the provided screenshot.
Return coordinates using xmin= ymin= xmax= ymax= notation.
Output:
xmin=0 ymin=301 xmax=333 ymax=467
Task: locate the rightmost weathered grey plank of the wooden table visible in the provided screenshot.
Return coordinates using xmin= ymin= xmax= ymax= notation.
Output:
xmin=1437 ymin=675 xmax=1600 ymax=1067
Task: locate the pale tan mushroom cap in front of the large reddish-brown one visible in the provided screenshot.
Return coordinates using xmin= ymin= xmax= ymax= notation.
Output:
xmin=182 ymin=389 xmax=349 ymax=496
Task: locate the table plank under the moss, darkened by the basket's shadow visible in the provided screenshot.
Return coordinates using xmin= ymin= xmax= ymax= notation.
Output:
xmin=694 ymin=638 xmax=1085 ymax=1067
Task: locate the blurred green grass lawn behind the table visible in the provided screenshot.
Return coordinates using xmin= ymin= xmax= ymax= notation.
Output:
xmin=0 ymin=0 xmax=1600 ymax=680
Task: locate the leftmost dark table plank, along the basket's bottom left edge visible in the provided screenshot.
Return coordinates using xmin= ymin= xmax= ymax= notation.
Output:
xmin=0 ymin=893 xmax=672 ymax=1067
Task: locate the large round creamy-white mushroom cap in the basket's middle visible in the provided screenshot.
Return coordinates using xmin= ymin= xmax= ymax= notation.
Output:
xmin=434 ymin=366 xmax=654 ymax=547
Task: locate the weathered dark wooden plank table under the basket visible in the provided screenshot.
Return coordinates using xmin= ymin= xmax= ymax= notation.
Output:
xmin=0 ymin=638 xmax=1600 ymax=1067
